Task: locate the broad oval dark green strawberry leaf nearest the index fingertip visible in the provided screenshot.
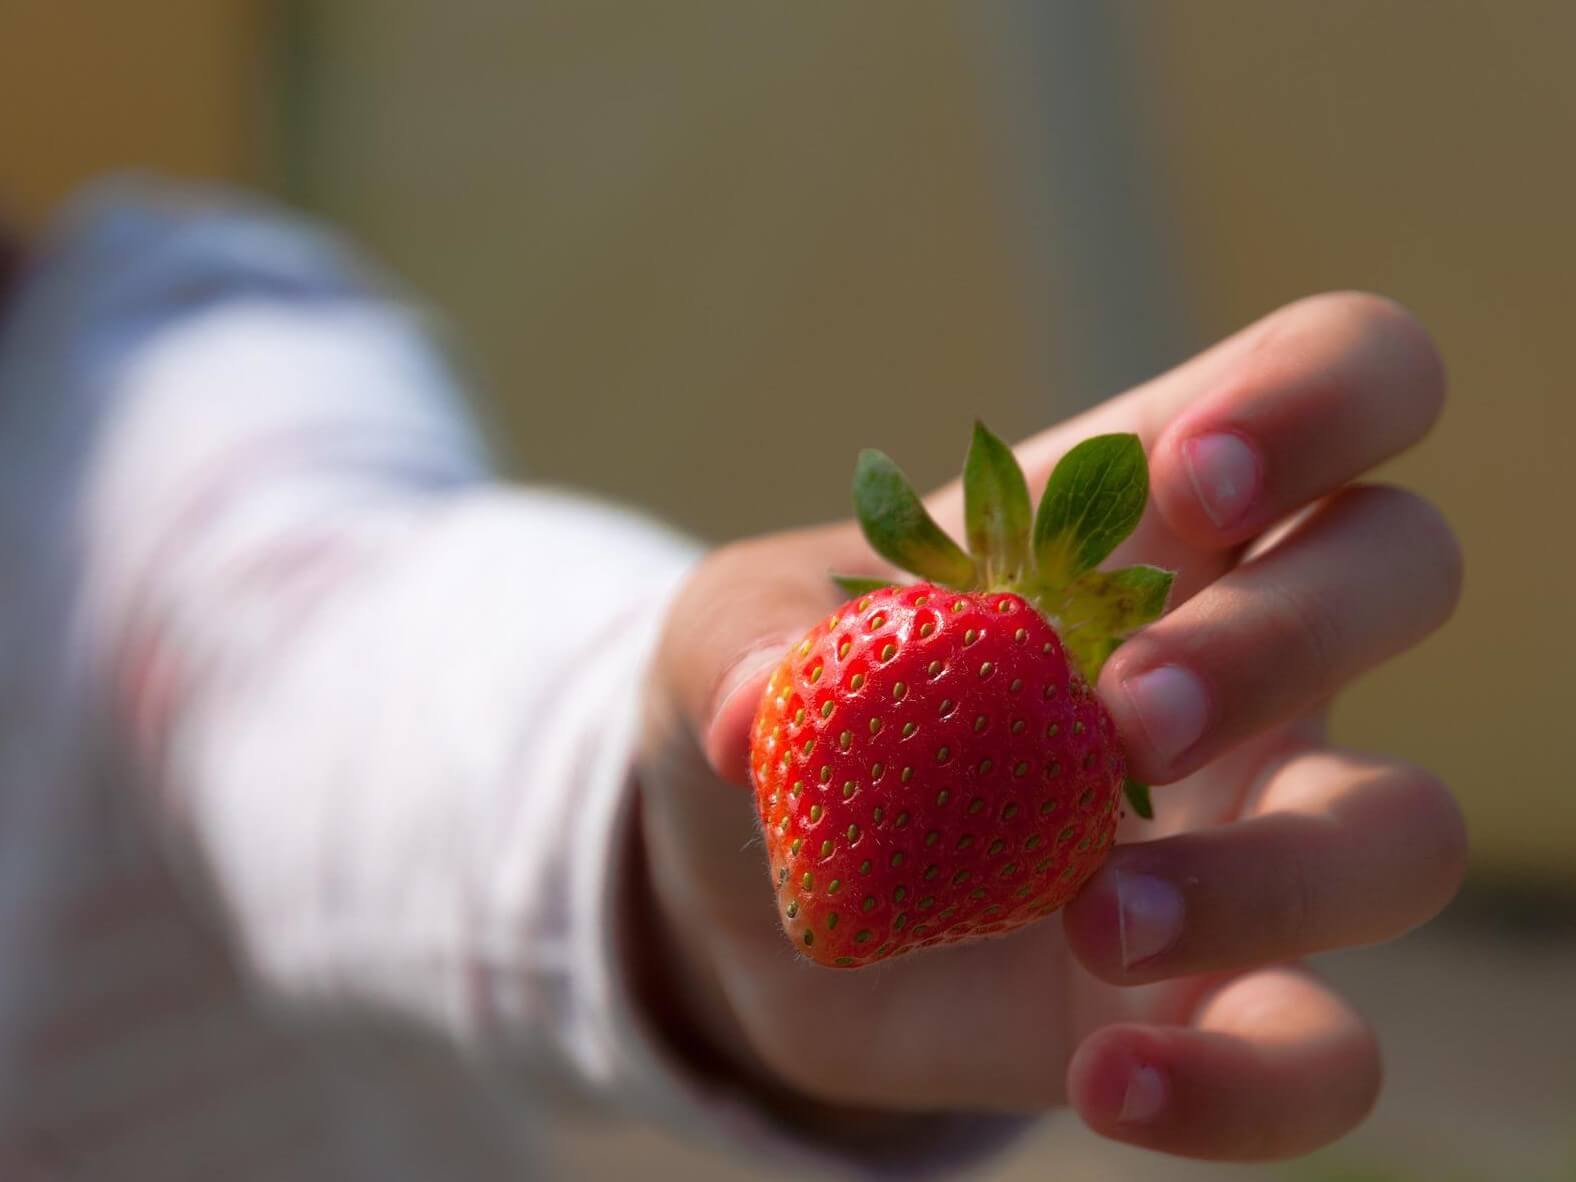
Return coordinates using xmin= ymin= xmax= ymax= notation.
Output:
xmin=1034 ymin=435 xmax=1149 ymax=589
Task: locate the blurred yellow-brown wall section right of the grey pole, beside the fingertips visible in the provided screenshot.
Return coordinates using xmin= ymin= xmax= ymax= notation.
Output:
xmin=1127 ymin=0 xmax=1576 ymax=883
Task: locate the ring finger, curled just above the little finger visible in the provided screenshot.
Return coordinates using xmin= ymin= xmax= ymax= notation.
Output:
xmin=1062 ymin=750 xmax=1467 ymax=985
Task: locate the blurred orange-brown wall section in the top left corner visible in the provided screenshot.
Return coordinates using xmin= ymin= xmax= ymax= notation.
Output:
xmin=0 ymin=0 xmax=266 ymax=225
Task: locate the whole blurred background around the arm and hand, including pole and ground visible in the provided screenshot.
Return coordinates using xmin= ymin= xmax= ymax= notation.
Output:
xmin=0 ymin=0 xmax=1576 ymax=1182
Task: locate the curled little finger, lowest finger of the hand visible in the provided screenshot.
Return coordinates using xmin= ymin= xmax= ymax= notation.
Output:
xmin=1067 ymin=969 xmax=1381 ymax=1162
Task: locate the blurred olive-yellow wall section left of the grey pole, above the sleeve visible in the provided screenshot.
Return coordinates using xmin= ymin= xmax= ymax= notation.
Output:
xmin=301 ymin=0 xmax=1043 ymax=537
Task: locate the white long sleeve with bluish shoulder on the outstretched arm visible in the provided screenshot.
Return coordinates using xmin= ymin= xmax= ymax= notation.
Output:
xmin=0 ymin=180 xmax=1015 ymax=1177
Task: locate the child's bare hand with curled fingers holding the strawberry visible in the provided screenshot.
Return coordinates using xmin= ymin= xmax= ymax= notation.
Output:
xmin=641 ymin=295 xmax=1466 ymax=1160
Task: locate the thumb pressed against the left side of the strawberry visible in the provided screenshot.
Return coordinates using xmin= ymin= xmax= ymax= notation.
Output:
xmin=657 ymin=526 xmax=872 ymax=783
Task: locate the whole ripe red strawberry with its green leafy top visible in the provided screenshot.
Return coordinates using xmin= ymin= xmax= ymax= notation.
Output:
xmin=750 ymin=424 xmax=1171 ymax=968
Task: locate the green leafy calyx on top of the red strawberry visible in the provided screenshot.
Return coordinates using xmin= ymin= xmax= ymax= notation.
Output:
xmin=835 ymin=422 xmax=1173 ymax=816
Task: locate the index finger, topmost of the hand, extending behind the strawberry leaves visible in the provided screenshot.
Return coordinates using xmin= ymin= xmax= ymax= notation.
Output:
xmin=935 ymin=292 xmax=1444 ymax=602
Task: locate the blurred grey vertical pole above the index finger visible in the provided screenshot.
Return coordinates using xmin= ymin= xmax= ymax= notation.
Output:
xmin=958 ymin=0 xmax=1195 ymax=416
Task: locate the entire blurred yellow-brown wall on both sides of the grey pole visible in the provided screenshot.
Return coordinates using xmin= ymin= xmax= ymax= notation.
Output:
xmin=0 ymin=0 xmax=1576 ymax=881
